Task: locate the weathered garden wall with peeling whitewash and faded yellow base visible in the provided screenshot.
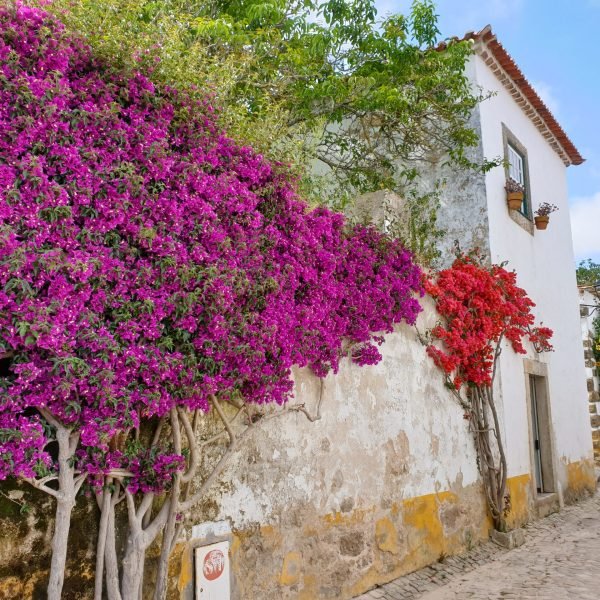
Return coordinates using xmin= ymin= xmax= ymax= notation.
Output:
xmin=0 ymin=302 xmax=594 ymax=600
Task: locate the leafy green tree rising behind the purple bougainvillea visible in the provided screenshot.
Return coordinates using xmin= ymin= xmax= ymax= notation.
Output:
xmin=41 ymin=0 xmax=491 ymax=259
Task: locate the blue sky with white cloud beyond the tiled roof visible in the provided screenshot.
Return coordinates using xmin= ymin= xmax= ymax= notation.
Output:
xmin=376 ymin=0 xmax=600 ymax=262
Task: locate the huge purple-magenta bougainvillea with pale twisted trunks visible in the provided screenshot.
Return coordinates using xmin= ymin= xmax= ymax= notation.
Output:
xmin=0 ymin=5 xmax=421 ymax=600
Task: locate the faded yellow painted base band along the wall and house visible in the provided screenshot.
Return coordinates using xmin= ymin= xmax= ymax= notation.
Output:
xmin=171 ymin=461 xmax=595 ymax=600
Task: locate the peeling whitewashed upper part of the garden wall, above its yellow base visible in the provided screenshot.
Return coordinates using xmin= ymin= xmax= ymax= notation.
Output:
xmin=220 ymin=302 xmax=479 ymax=526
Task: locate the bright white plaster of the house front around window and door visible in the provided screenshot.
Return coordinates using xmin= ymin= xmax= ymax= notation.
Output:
xmin=473 ymin=51 xmax=591 ymax=485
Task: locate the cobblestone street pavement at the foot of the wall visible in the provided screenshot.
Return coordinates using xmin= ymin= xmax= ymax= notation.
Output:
xmin=356 ymin=493 xmax=600 ymax=600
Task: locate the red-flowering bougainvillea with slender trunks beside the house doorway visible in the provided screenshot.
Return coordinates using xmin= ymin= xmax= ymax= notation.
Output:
xmin=425 ymin=252 xmax=552 ymax=531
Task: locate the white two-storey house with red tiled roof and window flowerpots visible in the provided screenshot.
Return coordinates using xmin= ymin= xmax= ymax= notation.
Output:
xmin=441 ymin=26 xmax=594 ymax=510
